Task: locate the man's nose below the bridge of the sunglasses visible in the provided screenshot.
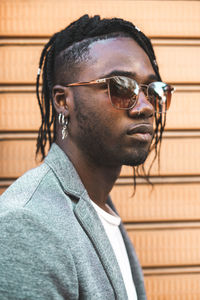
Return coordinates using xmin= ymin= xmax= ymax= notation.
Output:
xmin=128 ymin=90 xmax=154 ymax=118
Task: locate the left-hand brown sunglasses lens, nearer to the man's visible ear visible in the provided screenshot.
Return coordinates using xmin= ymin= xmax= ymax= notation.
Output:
xmin=109 ymin=76 xmax=139 ymax=109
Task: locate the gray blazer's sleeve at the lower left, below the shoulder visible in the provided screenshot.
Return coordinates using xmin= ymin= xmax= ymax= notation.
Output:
xmin=0 ymin=209 xmax=79 ymax=300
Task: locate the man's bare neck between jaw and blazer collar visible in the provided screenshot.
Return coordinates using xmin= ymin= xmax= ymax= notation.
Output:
xmin=58 ymin=139 xmax=121 ymax=212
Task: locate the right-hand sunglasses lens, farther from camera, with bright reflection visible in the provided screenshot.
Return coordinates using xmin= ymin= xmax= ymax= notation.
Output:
xmin=148 ymin=82 xmax=173 ymax=113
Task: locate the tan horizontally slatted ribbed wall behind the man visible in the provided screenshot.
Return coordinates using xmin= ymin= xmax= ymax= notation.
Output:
xmin=0 ymin=0 xmax=200 ymax=300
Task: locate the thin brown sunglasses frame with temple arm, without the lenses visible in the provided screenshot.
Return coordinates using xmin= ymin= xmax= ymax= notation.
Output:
xmin=66 ymin=76 xmax=175 ymax=114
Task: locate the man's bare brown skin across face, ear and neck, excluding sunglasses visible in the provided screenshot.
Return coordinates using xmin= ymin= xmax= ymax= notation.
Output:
xmin=53 ymin=37 xmax=156 ymax=211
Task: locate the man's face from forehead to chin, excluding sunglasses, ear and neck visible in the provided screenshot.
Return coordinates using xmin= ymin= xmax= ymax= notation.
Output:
xmin=68 ymin=37 xmax=156 ymax=166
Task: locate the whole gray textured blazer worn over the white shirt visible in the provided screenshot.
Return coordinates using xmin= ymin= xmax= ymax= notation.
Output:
xmin=0 ymin=144 xmax=146 ymax=300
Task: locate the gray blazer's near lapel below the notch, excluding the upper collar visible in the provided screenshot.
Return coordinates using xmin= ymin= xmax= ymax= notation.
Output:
xmin=74 ymin=193 xmax=128 ymax=300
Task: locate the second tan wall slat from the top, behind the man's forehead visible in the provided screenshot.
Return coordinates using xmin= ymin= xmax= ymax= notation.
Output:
xmin=0 ymin=44 xmax=200 ymax=84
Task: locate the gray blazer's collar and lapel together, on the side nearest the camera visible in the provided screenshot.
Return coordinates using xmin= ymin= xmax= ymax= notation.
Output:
xmin=45 ymin=144 xmax=127 ymax=299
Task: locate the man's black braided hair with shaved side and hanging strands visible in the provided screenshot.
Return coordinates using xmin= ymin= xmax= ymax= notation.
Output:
xmin=36 ymin=15 xmax=166 ymax=177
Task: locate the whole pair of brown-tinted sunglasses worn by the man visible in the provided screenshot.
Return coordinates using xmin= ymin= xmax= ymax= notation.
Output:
xmin=67 ymin=76 xmax=174 ymax=113
